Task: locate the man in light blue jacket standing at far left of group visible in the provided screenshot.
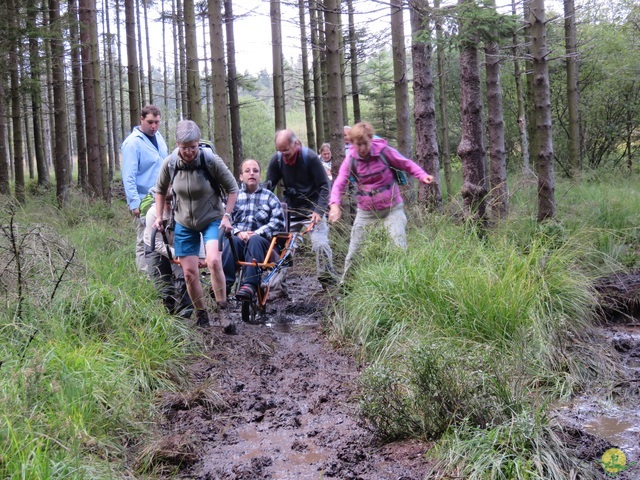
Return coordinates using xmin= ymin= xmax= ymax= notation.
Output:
xmin=122 ymin=105 xmax=169 ymax=272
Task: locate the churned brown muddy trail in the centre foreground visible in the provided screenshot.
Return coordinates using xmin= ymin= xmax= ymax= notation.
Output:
xmin=148 ymin=271 xmax=427 ymax=480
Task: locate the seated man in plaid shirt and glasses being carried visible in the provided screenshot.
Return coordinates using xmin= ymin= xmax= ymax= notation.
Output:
xmin=222 ymin=159 xmax=285 ymax=301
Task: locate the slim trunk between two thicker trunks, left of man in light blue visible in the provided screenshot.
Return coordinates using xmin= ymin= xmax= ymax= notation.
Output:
xmin=67 ymin=0 xmax=87 ymax=193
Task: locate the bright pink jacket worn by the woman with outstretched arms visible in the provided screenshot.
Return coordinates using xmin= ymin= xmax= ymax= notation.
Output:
xmin=329 ymin=137 xmax=427 ymax=210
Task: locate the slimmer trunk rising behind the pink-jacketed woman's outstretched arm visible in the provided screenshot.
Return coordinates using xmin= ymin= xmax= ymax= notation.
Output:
xmin=391 ymin=0 xmax=413 ymax=157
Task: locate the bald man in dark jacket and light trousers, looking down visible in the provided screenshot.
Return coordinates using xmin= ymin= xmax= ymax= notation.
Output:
xmin=267 ymin=129 xmax=338 ymax=287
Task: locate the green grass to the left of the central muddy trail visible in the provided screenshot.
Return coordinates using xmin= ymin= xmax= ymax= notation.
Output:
xmin=0 ymin=193 xmax=197 ymax=479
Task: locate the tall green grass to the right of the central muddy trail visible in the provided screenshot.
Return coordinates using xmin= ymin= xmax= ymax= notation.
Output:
xmin=330 ymin=174 xmax=640 ymax=478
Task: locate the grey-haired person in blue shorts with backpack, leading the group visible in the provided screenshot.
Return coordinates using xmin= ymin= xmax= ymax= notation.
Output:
xmin=155 ymin=120 xmax=238 ymax=334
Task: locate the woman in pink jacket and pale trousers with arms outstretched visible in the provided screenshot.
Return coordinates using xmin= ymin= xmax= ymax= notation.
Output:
xmin=329 ymin=122 xmax=433 ymax=279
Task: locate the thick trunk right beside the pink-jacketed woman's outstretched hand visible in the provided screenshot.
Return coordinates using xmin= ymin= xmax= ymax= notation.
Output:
xmin=409 ymin=0 xmax=442 ymax=211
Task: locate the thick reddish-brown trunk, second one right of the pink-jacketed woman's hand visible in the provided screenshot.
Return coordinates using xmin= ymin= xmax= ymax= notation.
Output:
xmin=458 ymin=0 xmax=487 ymax=224
